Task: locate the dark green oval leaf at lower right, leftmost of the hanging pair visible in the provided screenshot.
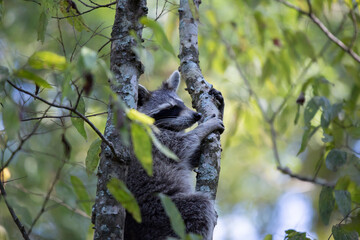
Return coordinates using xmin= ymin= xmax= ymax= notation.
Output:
xmin=319 ymin=187 xmax=335 ymax=225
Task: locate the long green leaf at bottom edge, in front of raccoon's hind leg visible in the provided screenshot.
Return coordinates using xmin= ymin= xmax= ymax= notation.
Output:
xmin=159 ymin=193 xmax=186 ymax=239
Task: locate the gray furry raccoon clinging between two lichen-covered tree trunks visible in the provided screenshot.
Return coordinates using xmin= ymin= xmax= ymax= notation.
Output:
xmin=125 ymin=71 xmax=224 ymax=240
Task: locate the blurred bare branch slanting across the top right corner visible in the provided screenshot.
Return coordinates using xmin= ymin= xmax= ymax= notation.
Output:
xmin=275 ymin=0 xmax=360 ymax=63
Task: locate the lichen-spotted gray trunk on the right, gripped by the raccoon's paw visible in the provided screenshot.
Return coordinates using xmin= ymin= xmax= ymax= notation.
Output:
xmin=179 ymin=0 xmax=224 ymax=200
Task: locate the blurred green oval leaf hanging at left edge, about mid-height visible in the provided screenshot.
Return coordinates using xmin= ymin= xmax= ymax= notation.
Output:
xmin=2 ymin=100 xmax=20 ymax=139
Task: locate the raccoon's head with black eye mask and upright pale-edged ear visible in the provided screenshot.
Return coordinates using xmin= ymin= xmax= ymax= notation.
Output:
xmin=138 ymin=71 xmax=201 ymax=131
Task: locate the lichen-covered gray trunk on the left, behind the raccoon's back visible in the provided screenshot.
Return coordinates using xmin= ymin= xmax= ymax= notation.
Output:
xmin=92 ymin=0 xmax=147 ymax=240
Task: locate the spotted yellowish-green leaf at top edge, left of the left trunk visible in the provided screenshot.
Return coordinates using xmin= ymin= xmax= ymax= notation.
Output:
xmin=60 ymin=0 xmax=87 ymax=32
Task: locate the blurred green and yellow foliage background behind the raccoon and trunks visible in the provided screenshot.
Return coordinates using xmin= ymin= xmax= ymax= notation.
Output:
xmin=0 ymin=0 xmax=360 ymax=239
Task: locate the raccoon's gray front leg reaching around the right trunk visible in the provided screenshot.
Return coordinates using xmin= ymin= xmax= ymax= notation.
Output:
xmin=180 ymin=117 xmax=225 ymax=169
